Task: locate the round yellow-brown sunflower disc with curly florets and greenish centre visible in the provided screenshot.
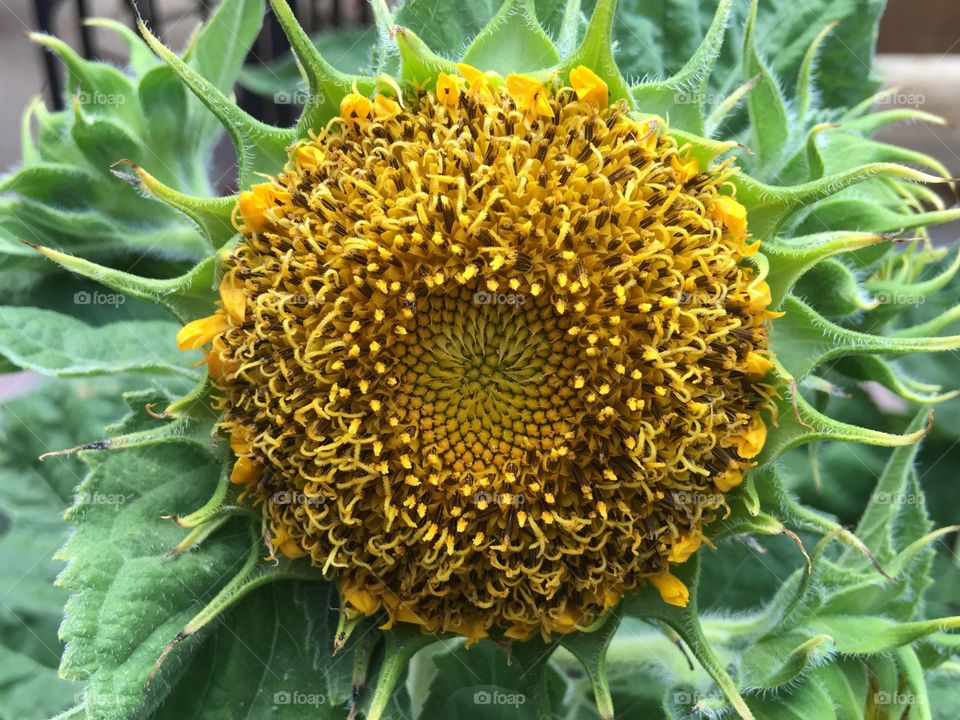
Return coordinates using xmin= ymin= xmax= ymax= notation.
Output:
xmin=186 ymin=65 xmax=774 ymax=640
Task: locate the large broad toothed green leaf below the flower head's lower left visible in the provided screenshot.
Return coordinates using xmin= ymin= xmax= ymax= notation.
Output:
xmin=59 ymin=442 xmax=249 ymax=720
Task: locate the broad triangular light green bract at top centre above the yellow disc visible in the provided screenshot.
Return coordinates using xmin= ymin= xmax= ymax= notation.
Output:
xmin=463 ymin=0 xmax=560 ymax=76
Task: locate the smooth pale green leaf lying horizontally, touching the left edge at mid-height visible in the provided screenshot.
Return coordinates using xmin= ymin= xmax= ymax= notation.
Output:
xmin=0 ymin=308 xmax=199 ymax=377
